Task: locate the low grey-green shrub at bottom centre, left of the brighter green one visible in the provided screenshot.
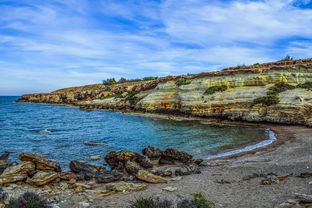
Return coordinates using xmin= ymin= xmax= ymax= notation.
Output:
xmin=129 ymin=197 xmax=173 ymax=208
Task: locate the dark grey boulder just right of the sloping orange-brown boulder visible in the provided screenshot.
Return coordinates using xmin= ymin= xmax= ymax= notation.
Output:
xmin=69 ymin=160 xmax=105 ymax=174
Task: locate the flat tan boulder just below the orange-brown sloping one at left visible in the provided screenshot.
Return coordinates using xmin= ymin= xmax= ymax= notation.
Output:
xmin=27 ymin=171 xmax=60 ymax=186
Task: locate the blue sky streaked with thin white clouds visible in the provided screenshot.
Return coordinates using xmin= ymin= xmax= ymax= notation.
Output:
xmin=0 ymin=0 xmax=312 ymax=95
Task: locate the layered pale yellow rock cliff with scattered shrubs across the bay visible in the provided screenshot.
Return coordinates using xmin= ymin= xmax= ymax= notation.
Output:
xmin=20 ymin=59 xmax=312 ymax=126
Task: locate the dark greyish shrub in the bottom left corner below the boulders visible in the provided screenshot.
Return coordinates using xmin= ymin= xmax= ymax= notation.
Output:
xmin=8 ymin=192 xmax=51 ymax=208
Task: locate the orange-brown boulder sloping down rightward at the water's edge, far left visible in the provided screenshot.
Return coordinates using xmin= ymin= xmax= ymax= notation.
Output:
xmin=19 ymin=152 xmax=61 ymax=172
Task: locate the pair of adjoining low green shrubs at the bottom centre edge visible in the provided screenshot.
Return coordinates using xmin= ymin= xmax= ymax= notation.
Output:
xmin=129 ymin=193 xmax=215 ymax=208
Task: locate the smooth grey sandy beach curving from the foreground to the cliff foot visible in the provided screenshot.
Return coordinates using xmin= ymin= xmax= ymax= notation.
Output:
xmin=83 ymin=126 xmax=312 ymax=208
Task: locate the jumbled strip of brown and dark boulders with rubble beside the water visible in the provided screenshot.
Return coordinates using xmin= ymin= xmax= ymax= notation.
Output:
xmin=0 ymin=147 xmax=203 ymax=207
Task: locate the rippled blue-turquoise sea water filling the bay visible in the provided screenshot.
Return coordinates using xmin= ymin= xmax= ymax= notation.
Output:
xmin=0 ymin=96 xmax=272 ymax=169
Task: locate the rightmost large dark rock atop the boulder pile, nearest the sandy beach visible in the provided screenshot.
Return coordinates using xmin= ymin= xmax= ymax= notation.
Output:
xmin=161 ymin=148 xmax=193 ymax=164
